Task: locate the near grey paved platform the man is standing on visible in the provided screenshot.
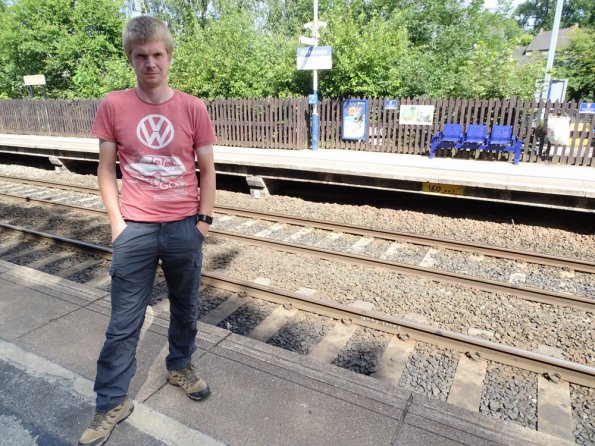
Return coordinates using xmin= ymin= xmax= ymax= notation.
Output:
xmin=0 ymin=261 xmax=567 ymax=446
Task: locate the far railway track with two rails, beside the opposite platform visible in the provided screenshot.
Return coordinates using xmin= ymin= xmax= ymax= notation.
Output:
xmin=0 ymin=176 xmax=595 ymax=311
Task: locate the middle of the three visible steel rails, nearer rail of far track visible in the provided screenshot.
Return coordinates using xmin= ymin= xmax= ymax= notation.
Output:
xmin=0 ymin=193 xmax=595 ymax=312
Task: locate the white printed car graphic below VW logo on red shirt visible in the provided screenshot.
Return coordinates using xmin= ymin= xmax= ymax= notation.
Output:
xmin=125 ymin=155 xmax=186 ymax=189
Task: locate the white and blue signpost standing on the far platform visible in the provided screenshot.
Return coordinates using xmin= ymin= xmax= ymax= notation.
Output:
xmin=297 ymin=0 xmax=333 ymax=150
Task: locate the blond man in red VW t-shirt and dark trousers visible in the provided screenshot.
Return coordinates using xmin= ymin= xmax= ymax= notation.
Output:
xmin=79 ymin=16 xmax=216 ymax=446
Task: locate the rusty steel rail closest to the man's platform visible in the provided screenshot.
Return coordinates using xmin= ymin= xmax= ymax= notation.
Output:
xmin=0 ymin=223 xmax=595 ymax=387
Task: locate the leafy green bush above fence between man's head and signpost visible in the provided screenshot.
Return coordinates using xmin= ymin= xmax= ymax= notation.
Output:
xmin=171 ymin=10 xmax=296 ymax=98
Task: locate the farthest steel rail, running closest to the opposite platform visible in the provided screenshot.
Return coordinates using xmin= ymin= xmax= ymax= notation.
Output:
xmin=0 ymin=175 xmax=595 ymax=274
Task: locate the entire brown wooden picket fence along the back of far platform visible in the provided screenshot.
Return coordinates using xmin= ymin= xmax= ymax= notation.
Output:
xmin=0 ymin=98 xmax=595 ymax=166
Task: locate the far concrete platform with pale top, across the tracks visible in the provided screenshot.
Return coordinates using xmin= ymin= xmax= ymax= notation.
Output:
xmin=0 ymin=134 xmax=595 ymax=213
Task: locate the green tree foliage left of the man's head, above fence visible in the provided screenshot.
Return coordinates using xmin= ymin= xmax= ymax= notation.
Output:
xmin=0 ymin=0 xmax=124 ymax=97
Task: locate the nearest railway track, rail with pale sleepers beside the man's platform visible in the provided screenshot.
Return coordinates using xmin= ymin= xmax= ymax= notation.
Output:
xmin=0 ymin=224 xmax=595 ymax=442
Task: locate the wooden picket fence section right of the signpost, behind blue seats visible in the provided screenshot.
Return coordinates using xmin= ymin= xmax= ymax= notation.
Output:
xmin=319 ymin=99 xmax=595 ymax=166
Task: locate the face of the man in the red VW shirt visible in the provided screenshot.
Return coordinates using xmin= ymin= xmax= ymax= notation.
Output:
xmin=129 ymin=40 xmax=171 ymax=88
